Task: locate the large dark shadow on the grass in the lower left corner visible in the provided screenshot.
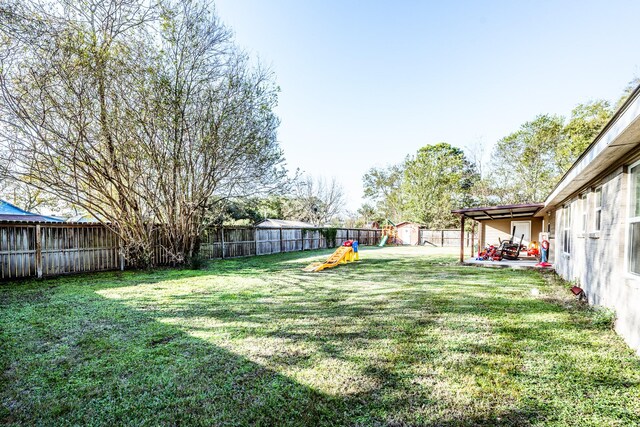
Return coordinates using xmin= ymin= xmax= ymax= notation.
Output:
xmin=0 ymin=284 xmax=360 ymax=426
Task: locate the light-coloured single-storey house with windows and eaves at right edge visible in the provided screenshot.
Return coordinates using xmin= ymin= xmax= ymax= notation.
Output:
xmin=454 ymin=86 xmax=640 ymax=353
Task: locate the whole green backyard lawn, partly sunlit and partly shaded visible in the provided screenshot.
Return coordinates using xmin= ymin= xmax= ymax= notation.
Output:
xmin=0 ymin=248 xmax=640 ymax=426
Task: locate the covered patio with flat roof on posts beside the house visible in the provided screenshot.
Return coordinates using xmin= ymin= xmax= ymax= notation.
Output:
xmin=451 ymin=203 xmax=544 ymax=268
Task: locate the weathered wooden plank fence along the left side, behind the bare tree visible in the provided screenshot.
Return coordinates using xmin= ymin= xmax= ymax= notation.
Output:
xmin=0 ymin=222 xmax=382 ymax=280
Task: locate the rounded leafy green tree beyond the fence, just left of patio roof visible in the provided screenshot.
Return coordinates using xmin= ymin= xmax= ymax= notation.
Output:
xmin=402 ymin=142 xmax=478 ymax=228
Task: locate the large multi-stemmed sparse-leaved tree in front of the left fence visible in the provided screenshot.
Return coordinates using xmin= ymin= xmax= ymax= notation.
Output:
xmin=0 ymin=0 xmax=283 ymax=265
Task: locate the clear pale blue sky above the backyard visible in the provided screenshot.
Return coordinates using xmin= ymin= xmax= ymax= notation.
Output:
xmin=215 ymin=0 xmax=640 ymax=210
